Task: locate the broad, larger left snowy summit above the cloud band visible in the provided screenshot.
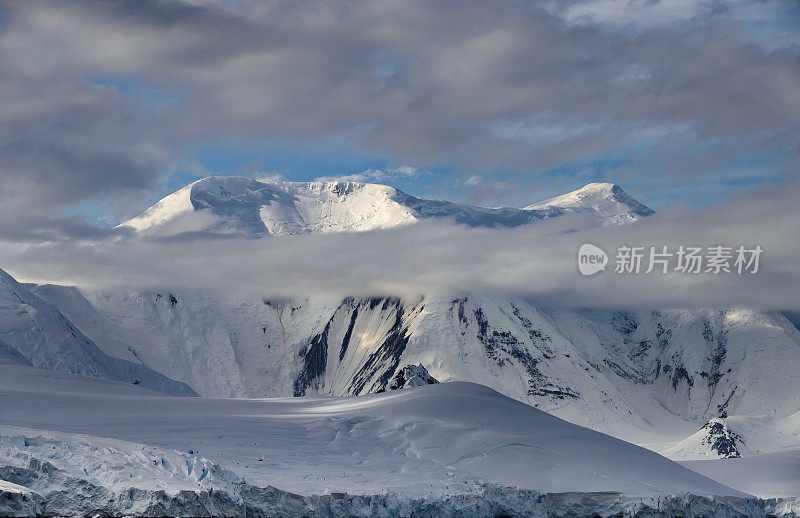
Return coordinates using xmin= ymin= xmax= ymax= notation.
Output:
xmin=121 ymin=176 xmax=416 ymax=236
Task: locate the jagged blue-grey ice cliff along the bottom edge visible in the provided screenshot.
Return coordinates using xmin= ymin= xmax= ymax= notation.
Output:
xmin=0 ymin=460 xmax=800 ymax=518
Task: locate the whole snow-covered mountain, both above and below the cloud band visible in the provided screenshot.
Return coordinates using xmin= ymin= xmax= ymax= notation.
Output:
xmin=6 ymin=177 xmax=800 ymax=480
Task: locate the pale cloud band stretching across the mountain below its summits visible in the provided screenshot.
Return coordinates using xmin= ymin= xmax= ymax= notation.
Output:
xmin=0 ymin=178 xmax=800 ymax=311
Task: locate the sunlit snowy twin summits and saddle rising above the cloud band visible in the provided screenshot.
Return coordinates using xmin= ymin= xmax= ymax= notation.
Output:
xmin=121 ymin=176 xmax=653 ymax=236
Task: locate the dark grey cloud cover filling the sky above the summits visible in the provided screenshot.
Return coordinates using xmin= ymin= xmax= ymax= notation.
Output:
xmin=0 ymin=0 xmax=800 ymax=240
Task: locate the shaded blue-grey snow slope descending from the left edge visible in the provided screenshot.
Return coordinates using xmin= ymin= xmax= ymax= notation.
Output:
xmin=0 ymin=270 xmax=196 ymax=395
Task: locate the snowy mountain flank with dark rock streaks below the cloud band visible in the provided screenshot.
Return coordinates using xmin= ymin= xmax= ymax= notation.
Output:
xmin=25 ymin=286 xmax=800 ymax=464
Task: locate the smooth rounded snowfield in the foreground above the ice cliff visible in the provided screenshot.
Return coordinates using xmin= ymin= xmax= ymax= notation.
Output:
xmin=0 ymin=365 xmax=742 ymax=496
